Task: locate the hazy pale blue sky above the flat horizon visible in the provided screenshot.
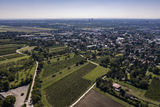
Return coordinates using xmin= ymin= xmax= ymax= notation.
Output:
xmin=0 ymin=0 xmax=160 ymax=19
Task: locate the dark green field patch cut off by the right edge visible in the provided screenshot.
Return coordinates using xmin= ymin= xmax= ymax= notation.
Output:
xmin=145 ymin=78 xmax=160 ymax=101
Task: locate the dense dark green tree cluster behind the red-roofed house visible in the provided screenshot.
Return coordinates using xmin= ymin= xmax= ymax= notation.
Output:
xmin=97 ymin=51 xmax=151 ymax=89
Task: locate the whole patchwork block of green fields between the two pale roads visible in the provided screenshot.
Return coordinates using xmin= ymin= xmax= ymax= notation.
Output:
xmin=40 ymin=52 xmax=115 ymax=107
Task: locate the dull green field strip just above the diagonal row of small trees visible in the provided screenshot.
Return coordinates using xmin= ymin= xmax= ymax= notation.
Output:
xmin=42 ymin=56 xmax=83 ymax=77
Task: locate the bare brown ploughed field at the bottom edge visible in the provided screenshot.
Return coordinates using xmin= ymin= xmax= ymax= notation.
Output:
xmin=74 ymin=89 xmax=124 ymax=107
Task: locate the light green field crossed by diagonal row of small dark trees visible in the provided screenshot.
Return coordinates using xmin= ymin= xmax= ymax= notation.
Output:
xmin=40 ymin=53 xmax=86 ymax=106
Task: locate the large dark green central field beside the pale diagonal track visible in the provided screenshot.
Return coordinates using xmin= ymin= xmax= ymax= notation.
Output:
xmin=45 ymin=63 xmax=96 ymax=107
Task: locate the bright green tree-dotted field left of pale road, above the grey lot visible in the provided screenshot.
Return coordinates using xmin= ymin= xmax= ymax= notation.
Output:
xmin=0 ymin=54 xmax=35 ymax=90
